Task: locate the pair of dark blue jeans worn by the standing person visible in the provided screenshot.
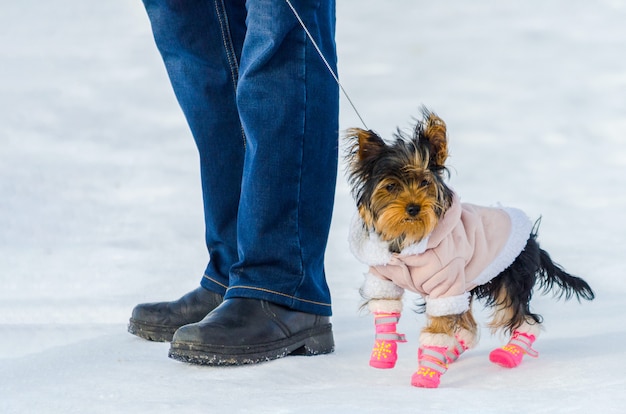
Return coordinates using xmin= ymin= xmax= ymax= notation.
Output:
xmin=144 ymin=0 xmax=339 ymax=315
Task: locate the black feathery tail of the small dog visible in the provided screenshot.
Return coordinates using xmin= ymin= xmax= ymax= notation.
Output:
xmin=536 ymin=248 xmax=596 ymax=302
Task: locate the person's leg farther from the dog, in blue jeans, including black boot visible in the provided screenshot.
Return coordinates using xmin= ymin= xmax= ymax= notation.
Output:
xmin=129 ymin=0 xmax=246 ymax=341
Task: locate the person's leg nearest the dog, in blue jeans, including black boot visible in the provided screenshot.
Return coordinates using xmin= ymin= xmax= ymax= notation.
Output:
xmin=170 ymin=0 xmax=338 ymax=365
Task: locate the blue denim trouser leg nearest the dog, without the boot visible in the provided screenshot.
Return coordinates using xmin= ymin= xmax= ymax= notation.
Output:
xmin=225 ymin=0 xmax=339 ymax=315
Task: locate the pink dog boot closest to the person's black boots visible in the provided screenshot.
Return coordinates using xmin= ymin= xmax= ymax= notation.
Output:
xmin=370 ymin=312 xmax=406 ymax=369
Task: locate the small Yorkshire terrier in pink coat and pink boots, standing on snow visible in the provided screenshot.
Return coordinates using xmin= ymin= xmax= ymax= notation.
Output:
xmin=346 ymin=108 xmax=595 ymax=388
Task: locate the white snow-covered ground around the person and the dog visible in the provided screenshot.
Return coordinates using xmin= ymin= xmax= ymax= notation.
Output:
xmin=0 ymin=0 xmax=626 ymax=414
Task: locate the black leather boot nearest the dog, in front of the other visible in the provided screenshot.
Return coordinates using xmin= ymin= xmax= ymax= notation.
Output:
xmin=169 ymin=298 xmax=335 ymax=365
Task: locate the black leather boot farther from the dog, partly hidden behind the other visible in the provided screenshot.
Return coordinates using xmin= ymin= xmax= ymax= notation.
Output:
xmin=128 ymin=287 xmax=223 ymax=342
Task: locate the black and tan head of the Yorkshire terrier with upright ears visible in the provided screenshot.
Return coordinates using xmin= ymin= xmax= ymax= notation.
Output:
xmin=346 ymin=109 xmax=453 ymax=251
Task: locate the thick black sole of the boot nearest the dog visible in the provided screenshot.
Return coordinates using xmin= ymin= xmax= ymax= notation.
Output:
xmin=168 ymin=324 xmax=335 ymax=366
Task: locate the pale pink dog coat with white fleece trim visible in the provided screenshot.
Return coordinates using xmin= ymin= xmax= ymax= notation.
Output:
xmin=350 ymin=195 xmax=532 ymax=316
